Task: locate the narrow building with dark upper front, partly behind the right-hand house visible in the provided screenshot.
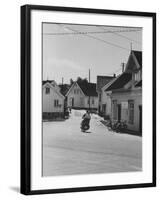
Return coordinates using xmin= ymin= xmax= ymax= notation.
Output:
xmin=96 ymin=75 xmax=115 ymax=116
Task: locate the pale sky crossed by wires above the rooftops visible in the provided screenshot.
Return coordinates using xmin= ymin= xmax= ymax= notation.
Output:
xmin=42 ymin=23 xmax=142 ymax=84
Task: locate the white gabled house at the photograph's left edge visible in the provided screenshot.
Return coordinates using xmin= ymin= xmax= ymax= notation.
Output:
xmin=42 ymin=81 xmax=65 ymax=119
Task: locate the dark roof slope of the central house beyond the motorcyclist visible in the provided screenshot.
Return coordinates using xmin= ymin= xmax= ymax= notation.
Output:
xmin=77 ymin=82 xmax=98 ymax=97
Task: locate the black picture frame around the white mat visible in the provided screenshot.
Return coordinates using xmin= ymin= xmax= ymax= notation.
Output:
xmin=20 ymin=5 xmax=156 ymax=195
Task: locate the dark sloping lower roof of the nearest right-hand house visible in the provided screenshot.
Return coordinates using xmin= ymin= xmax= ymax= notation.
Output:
xmin=105 ymin=72 xmax=132 ymax=91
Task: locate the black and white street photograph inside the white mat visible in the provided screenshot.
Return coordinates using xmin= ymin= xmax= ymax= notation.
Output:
xmin=42 ymin=22 xmax=143 ymax=177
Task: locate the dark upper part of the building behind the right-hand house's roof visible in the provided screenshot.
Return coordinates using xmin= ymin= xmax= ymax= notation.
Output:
xmin=97 ymin=76 xmax=115 ymax=92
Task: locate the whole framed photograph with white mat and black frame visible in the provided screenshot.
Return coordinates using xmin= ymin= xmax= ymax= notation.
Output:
xmin=21 ymin=5 xmax=156 ymax=195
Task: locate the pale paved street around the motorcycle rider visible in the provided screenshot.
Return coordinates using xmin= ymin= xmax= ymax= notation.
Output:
xmin=43 ymin=110 xmax=142 ymax=176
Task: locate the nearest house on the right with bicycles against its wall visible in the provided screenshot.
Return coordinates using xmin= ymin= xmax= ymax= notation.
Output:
xmin=105 ymin=51 xmax=142 ymax=133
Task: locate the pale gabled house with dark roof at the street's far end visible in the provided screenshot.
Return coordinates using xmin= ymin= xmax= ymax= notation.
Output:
xmin=66 ymin=82 xmax=98 ymax=110
